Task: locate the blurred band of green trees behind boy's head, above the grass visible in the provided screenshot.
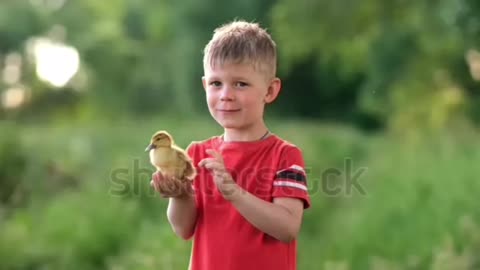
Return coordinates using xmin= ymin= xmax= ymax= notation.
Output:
xmin=0 ymin=0 xmax=480 ymax=130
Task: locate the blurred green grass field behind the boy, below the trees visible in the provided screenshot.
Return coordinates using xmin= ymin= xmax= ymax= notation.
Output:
xmin=0 ymin=118 xmax=480 ymax=270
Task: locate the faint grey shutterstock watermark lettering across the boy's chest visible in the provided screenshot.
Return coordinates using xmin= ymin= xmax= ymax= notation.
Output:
xmin=109 ymin=158 xmax=368 ymax=197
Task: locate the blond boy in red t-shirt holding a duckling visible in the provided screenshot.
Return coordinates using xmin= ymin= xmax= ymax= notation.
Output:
xmin=152 ymin=21 xmax=310 ymax=270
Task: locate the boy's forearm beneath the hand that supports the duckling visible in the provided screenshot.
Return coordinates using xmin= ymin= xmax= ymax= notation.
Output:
xmin=167 ymin=195 xmax=197 ymax=239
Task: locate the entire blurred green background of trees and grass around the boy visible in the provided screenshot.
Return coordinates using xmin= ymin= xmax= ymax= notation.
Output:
xmin=0 ymin=0 xmax=480 ymax=270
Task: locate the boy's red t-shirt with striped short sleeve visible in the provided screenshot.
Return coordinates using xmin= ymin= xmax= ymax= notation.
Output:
xmin=188 ymin=135 xmax=310 ymax=270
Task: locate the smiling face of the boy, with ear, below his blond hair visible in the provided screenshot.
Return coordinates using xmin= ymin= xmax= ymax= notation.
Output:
xmin=202 ymin=62 xmax=280 ymax=133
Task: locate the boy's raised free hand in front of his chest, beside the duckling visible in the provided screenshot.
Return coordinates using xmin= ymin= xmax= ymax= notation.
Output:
xmin=198 ymin=149 xmax=238 ymax=200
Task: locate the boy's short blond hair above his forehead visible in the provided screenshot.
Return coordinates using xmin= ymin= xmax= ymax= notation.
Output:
xmin=203 ymin=21 xmax=277 ymax=78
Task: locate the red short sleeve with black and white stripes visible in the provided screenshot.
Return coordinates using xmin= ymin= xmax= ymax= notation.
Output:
xmin=272 ymin=146 xmax=310 ymax=209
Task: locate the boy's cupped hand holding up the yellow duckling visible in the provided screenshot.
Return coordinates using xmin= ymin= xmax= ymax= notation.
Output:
xmin=150 ymin=171 xmax=193 ymax=198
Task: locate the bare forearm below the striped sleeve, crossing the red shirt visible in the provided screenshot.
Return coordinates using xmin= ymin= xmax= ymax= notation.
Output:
xmin=228 ymin=186 xmax=300 ymax=242
